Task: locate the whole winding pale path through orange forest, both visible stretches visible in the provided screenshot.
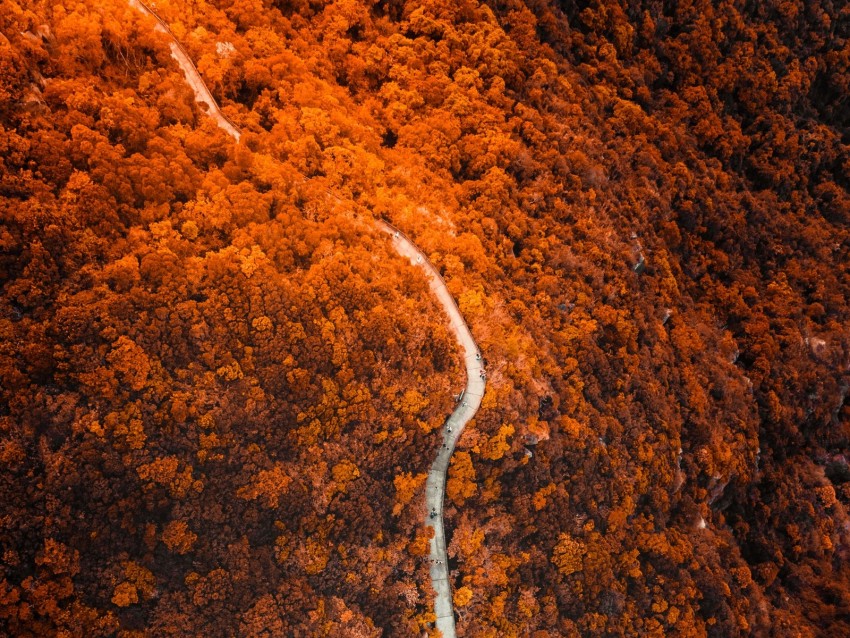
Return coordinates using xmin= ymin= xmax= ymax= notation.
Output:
xmin=128 ymin=0 xmax=486 ymax=638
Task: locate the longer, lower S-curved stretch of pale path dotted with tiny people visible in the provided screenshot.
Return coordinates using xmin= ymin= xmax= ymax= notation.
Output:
xmin=378 ymin=221 xmax=486 ymax=638
